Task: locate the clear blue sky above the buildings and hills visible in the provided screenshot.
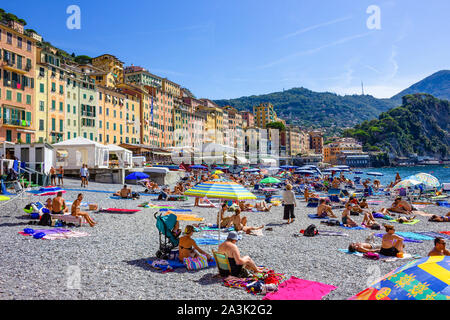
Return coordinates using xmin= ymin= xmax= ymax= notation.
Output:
xmin=4 ymin=0 xmax=450 ymax=99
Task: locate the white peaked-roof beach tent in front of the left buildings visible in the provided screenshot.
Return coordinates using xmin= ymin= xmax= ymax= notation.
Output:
xmin=52 ymin=137 xmax=109 ymax=169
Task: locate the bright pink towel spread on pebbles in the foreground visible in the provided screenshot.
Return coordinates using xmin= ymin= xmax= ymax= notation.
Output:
xmin=263 ymin=277 xmax=337 ymax=300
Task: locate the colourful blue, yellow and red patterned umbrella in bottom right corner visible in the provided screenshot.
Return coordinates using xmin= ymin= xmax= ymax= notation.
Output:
xmin=349 ymin=256 xmax=450 ymax=300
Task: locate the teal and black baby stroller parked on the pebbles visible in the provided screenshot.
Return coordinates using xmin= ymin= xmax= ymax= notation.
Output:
xmin=154 ymin=212 xmax=179 ymax=260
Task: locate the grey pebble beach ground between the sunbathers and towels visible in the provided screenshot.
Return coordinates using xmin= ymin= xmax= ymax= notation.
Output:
xmin=0 ymin=179 xmax=449 ymax=300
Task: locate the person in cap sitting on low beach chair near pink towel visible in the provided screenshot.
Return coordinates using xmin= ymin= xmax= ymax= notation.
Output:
xmin=218 ymin=231 xmax=262 ymax=277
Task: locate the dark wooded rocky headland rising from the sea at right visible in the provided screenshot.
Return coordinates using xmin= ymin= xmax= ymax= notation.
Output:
xmin=344 ymin=94 xmax=450 ymax=158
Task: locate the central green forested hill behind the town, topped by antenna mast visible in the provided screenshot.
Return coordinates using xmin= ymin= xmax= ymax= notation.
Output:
xmin=214 ymin=88 xmax=395 ymax=134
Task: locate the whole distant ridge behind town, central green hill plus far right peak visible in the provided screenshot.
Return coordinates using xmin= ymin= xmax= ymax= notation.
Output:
xmin=215 ymin=70 xmax=450 ymax=134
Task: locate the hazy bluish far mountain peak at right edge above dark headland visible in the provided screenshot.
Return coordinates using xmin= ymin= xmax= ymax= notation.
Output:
xmin=390 ymin=70 xmax=450 ymax=105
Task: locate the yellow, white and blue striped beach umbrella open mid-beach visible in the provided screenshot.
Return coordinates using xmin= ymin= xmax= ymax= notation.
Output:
xmin=184 ymin=180 xmax=256 ymax=200
